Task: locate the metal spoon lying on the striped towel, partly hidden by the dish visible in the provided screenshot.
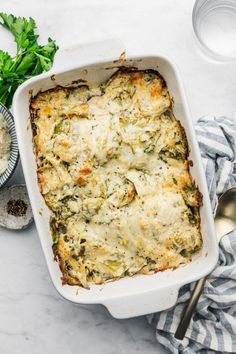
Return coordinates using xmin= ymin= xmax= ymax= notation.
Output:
xmin=175 ymin=187 xmax=236 ymax=340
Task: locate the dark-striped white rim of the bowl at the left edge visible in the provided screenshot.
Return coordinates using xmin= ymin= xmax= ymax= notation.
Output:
xmin=0 ymin=102 xmax=19 ymax=188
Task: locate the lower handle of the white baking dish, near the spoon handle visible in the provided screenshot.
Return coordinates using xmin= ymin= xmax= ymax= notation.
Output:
xmin=103 ymin=285 xmax=180 ymax=319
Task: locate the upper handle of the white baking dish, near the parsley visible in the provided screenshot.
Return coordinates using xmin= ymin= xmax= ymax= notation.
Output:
xmin=50 ymin=38 xmax=125 ymax=73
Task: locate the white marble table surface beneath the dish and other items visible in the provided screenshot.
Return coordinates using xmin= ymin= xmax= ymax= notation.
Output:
xmin=0 ymin=0 xmax=236 ymax=354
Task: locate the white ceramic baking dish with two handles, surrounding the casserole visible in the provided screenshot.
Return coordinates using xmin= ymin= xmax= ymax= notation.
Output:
xmin=13 ymin=40 xmax=218 ymax=318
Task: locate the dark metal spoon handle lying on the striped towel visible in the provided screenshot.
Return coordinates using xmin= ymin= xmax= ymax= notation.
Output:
xmin=175 ymin=277 xmax=207 ymax=340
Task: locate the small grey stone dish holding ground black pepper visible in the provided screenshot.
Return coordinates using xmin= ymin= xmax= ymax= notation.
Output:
xmin=0 ymin=184 xmax=33 ymax=230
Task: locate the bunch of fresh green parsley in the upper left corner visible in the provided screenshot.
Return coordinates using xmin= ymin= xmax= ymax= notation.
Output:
xmin=0 ymin=13 xmax=58 ymax=107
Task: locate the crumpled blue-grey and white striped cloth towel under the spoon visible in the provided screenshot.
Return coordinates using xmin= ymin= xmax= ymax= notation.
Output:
xmin=149 ymin=116 xmax=236 ymax=354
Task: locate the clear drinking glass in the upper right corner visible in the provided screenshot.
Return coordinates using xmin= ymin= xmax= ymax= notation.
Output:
xmin=192 ymin=0 xmax=236 ymax=61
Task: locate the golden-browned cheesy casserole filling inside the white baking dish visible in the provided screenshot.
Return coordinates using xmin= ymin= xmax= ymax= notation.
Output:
xmin=31 ymin=69 xmax=202 ymax=287
